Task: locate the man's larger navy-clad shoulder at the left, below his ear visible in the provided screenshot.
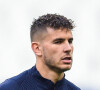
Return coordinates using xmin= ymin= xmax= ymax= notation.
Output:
xmin=0 ymin=66 xmax=34 ymax=90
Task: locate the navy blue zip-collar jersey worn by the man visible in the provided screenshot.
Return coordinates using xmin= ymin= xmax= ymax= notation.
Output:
xmin=0 ymin=66 xmax=80 ymax=90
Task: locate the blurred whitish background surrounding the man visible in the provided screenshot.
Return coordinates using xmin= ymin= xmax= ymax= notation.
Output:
xmin=0 ymin=0 xmax=100 ymax=90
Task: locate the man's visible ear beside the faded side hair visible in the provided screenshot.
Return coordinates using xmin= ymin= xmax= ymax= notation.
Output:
xmin=31 ymin=42 xmax=42 ymax=56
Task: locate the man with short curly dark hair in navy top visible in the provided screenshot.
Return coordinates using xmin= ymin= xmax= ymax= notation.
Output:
xmin=0 ymin=14 xmax=80 ymax=90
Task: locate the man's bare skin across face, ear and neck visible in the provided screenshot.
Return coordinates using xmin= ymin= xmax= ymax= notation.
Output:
xmin=32 ymin=28 xmax=73 ymax=83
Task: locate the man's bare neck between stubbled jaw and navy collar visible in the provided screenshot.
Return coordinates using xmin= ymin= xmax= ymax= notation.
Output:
xmin=36 ymin=61 xmax=64 ymax=84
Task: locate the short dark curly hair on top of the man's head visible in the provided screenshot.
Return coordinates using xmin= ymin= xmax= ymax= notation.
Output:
xmin=30 ymin=14 xmax=74 ymax=42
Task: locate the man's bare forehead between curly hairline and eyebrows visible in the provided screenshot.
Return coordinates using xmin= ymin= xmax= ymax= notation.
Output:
xmin=46 ymin=28 xmax=73 ymax=39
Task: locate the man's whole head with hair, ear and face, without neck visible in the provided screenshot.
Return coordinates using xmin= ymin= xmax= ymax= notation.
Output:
xmin=30 ymin=14 xmax=74 ymax=72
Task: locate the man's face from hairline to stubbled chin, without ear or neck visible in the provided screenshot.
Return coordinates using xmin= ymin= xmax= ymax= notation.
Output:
xmin=42 ymin=28 xmax=73 ymax=72
